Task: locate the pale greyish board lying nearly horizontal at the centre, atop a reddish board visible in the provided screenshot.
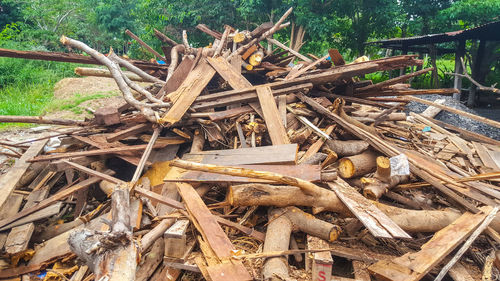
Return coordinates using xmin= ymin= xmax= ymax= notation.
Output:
xmin=186 ymin=143 xmax=298 ymax=165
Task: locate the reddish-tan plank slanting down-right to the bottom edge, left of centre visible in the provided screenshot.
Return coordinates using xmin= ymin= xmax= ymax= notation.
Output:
xmin=177 ymin=183 xmax=252 ymax=281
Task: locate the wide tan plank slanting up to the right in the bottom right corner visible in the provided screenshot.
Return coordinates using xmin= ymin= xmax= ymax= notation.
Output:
xmin=368 ymin=207 xmax=491 ymax=281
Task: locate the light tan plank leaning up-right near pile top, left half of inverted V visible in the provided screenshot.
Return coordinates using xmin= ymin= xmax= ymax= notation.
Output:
xmin=158 ymin=59 xmax=215 ymax=124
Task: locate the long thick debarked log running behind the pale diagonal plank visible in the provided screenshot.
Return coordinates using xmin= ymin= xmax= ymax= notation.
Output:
xmin=227 ymin=184 xmax=480 ymax=233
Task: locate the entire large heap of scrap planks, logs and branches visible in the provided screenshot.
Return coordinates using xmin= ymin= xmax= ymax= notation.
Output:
xmin=0 ymin=7 xmax=500 ymax=281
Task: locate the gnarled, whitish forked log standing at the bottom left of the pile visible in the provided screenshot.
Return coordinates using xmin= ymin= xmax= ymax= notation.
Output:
xmin=68 ymin=187 xmax=138 ymax=281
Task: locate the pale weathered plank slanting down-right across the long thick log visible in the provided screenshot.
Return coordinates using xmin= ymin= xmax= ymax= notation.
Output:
xmin=328 ymin=178 xmax=411 ymax=239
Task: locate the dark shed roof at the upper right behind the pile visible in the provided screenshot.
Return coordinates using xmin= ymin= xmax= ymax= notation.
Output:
xmin=366 ymin=21 xmax=500 ymax=47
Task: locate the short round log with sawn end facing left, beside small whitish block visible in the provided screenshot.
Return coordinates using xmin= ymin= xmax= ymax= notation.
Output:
xmin=337 ymin=150 xmax=377 ymax=179
